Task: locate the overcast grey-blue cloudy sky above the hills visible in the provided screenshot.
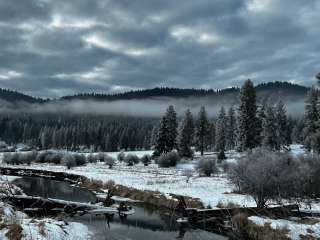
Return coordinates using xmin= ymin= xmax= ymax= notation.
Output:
xmin=0 ymin=0 xmax=320 ymax=97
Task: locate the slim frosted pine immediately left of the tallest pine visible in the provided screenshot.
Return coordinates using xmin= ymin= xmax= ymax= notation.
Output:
xmin=226 ymin=107 xmax=237 ymax=150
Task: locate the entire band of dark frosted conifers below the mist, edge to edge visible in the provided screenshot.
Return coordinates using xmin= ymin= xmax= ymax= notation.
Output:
xmin=0 ymin=80 xmax=308 ymax=155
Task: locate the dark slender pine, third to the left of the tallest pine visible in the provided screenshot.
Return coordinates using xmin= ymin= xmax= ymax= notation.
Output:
xmin=196 ymin=106 xmax=209 ymax=156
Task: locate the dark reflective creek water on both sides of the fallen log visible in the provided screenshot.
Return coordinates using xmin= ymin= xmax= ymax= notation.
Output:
xmin=13 ymin=177 xmax=226 ymax=240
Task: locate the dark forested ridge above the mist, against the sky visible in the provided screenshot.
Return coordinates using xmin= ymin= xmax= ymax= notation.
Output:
xmin=0 ymin=82 xmax=310 ymax=103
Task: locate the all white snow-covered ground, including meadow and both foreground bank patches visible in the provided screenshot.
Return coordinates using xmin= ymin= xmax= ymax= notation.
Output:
xmin=0 ymin=145 xmax=320 ymax=239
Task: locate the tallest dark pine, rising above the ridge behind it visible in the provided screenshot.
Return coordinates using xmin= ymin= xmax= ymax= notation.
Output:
xmin=238 ymin=80 xmax=260 ymax=151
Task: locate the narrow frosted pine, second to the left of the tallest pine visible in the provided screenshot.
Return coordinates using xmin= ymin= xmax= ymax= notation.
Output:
xmin=216 ymin=107 xmax=227 ymax=152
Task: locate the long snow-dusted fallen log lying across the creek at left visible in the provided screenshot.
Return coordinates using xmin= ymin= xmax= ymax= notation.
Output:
xmin=1 ymin=195 xmax=135 ymax=216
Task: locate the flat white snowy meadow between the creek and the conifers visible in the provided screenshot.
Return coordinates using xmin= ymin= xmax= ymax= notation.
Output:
xmin=0 ymin=145 xmax=310 ymax=208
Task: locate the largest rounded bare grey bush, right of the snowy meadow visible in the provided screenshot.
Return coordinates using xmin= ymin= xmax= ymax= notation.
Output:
xmin=229 ymin=148 xmax=304 ymax=207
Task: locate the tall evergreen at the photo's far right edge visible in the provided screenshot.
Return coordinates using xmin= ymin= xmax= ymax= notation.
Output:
xmin=303 ymin=88 xmax=319 ymax=151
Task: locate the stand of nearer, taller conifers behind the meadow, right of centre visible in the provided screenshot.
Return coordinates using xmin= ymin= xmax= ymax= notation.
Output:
xmin=154 ymin=80 xmax=299 ymax=159
